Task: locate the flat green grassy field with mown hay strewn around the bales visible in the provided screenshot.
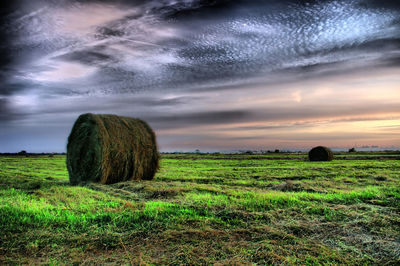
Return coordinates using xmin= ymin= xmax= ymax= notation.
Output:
xmin=0 ymin=153 xmax=400 ymax=265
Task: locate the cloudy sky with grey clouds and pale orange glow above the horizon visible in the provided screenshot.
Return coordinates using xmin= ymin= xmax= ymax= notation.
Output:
xmin=0 ymin=0 xmax=400 ymax=152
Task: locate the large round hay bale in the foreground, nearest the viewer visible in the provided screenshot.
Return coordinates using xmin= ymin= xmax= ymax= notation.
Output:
xmin=67 ymin=114 xmax=159 ymax=184
